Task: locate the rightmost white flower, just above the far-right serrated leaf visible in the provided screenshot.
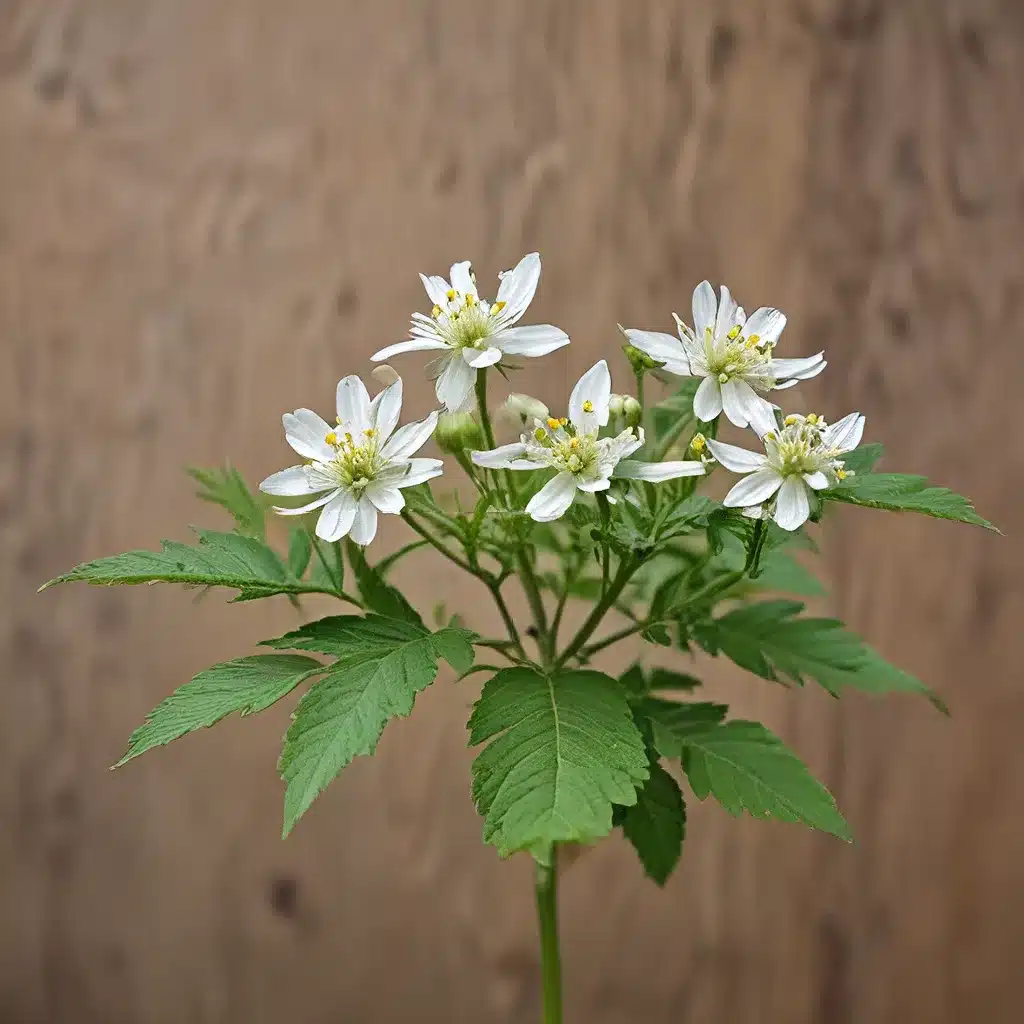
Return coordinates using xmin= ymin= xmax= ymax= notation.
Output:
xmin=707 ymin=413 xmax=864 ymax=530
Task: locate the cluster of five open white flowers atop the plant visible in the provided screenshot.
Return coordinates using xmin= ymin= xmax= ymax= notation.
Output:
xmin=260 ymin=253 xmax=864 ymax=545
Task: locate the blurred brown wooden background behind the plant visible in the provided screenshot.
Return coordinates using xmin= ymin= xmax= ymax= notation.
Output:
xmin=0 ymin=0 xmax=1024 ymax=1024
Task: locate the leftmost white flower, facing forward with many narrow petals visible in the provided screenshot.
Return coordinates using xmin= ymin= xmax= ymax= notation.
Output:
xmin=259 ymin=376 xmax=442 ymax=545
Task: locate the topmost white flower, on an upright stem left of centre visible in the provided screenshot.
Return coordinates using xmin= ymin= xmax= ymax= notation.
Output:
xmin=372 ymin=253 xmax=569 ymax=413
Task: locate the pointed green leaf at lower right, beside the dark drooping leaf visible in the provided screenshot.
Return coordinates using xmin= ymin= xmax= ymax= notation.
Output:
xmin=671 ymin=721 xmax=851 ymax=840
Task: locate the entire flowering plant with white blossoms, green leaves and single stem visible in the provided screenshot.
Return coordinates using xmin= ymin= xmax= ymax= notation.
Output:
xmin=39 ymin=253 xmax=994 ymax=1022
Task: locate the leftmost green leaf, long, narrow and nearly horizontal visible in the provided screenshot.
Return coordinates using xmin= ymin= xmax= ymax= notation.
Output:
xmin=40 ymin=530 xmax=324 ymax=601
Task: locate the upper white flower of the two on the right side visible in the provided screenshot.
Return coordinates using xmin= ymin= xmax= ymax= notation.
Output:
xmin=626 ymin=281 xmax=825 ymax=436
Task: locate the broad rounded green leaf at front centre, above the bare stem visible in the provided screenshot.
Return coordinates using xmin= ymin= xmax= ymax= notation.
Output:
xmin=469 ymin=668 xmax=648 ymax=855
